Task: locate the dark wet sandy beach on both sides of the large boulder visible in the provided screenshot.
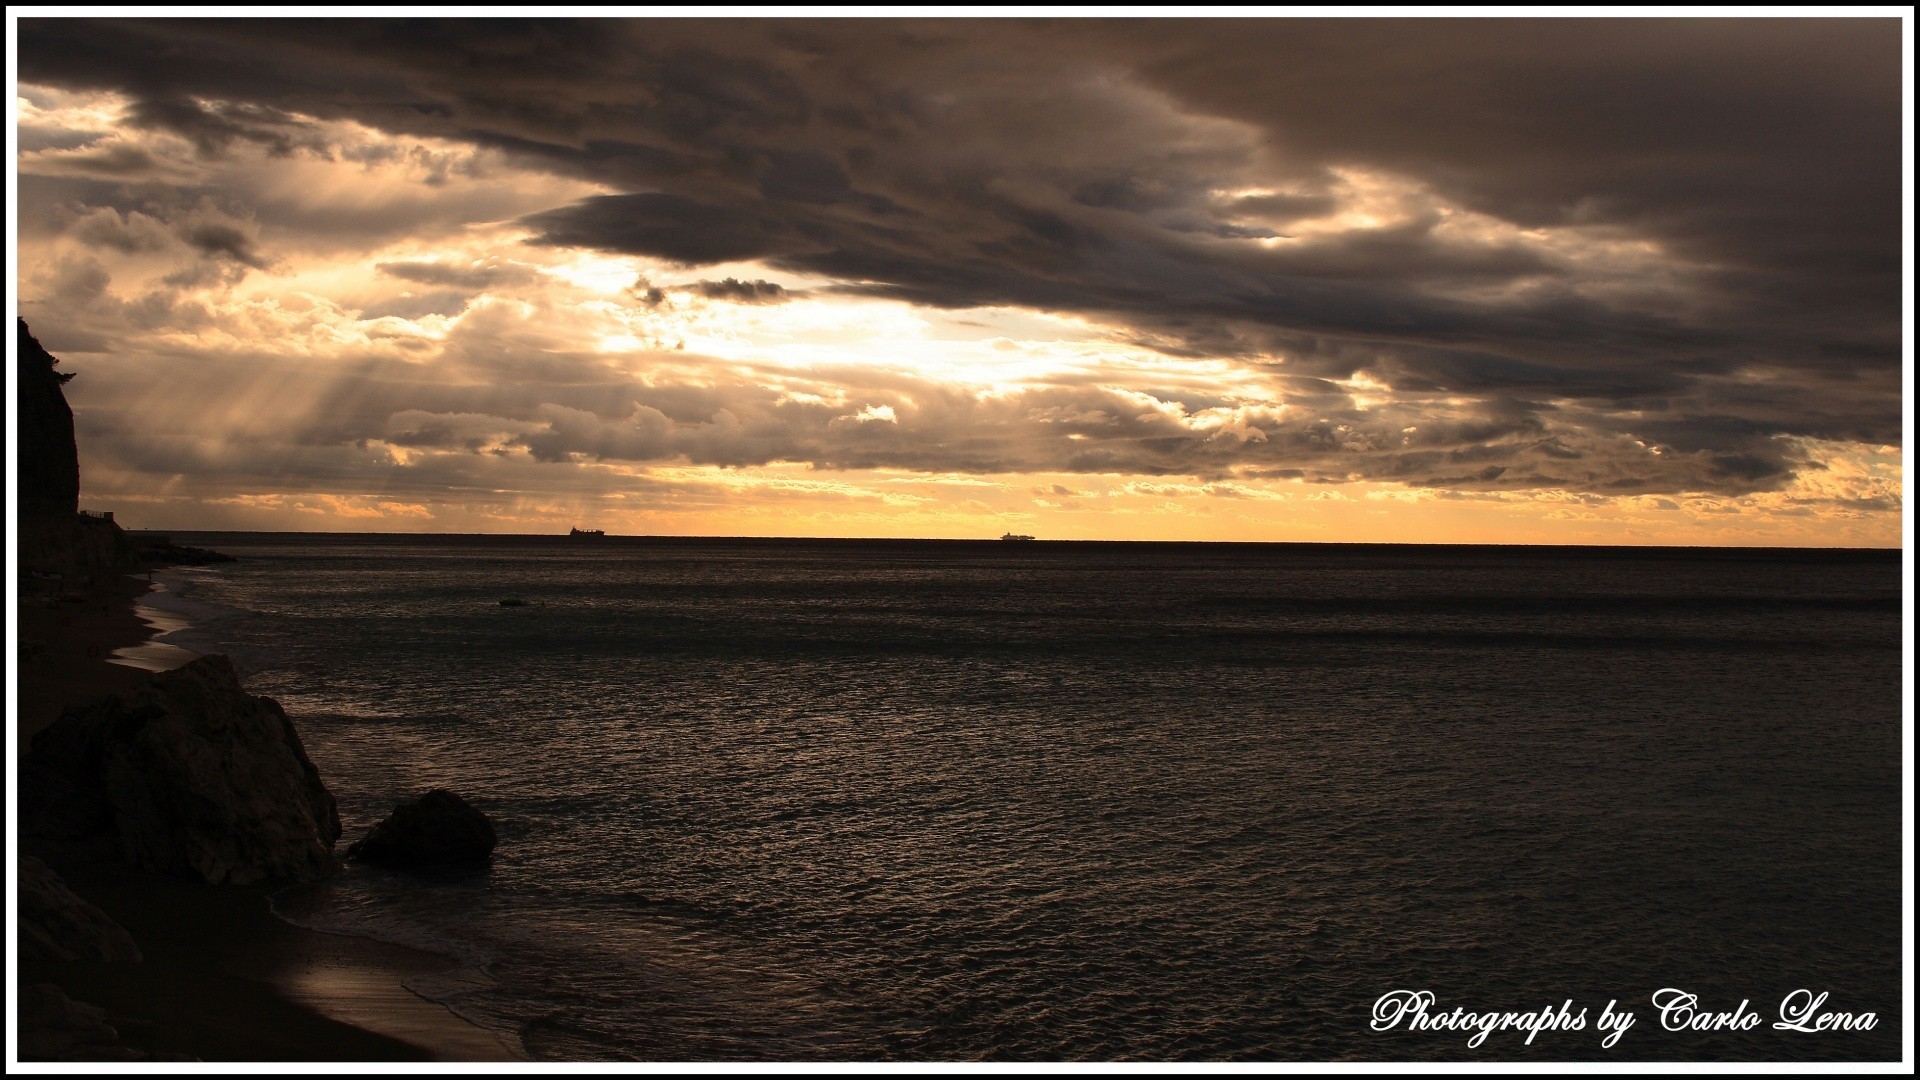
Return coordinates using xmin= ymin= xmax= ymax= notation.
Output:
xmin=15 ymin=571 xmax=526 ymax=1063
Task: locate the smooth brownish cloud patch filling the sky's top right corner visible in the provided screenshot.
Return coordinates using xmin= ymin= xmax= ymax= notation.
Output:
xmin=1091 ymin=19 xmax=1899 ymax=269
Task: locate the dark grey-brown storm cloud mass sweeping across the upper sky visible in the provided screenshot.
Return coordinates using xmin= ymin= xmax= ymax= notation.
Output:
xmin=19 ymin=19 xmax=1901 ymax=490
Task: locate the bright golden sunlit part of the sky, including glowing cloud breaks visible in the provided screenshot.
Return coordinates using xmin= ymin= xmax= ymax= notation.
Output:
xmin=17 ymin=78 xmax=1903 ymax=546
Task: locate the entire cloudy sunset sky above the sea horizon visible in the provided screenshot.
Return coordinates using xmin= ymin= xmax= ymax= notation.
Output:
xmin=15 ymin=17 xmax=1905 ymax=548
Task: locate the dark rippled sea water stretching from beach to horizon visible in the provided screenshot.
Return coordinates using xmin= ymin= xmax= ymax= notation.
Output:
xmin=142 ymin=534 xmax=1901 ymax=1061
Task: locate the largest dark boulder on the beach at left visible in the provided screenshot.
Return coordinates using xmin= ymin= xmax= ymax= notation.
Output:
xmin=21 ymin=655 xmax=340 ymax=884
